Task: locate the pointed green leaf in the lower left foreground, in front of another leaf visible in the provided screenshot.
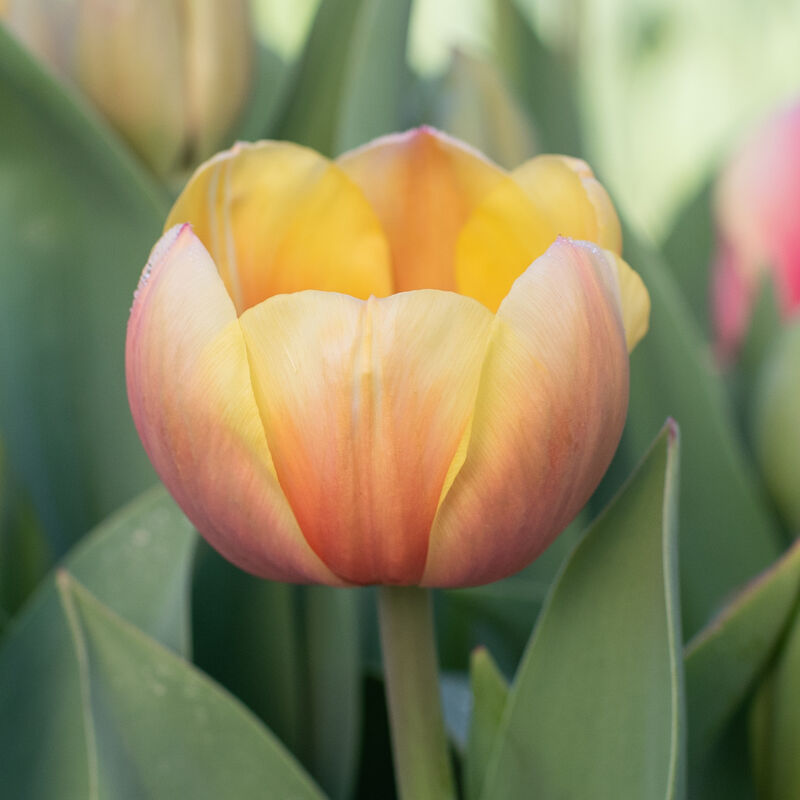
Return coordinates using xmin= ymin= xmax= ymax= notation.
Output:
xmin=61 ymin=572 xmax=322 ymax=800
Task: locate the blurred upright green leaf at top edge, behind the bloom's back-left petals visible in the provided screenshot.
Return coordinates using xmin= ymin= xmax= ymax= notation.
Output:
xmin=280 ymin=0 xmax=411 ymax=155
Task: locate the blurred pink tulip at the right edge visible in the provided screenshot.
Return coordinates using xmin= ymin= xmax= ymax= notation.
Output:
xmin=712 ymin=104 xmax=800 ymax=359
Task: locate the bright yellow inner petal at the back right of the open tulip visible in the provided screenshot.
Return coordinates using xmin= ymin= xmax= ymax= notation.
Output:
xmin=456 ymin=156 xmax=621 ymax=311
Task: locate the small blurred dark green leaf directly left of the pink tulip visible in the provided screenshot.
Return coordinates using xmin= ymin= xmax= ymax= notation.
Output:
xmin=662 ymin=181 xmax=715 ymax=339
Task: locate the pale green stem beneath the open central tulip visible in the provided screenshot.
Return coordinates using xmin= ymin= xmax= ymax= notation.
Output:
xmin=379 ymin=586 xmax=457 ymax=800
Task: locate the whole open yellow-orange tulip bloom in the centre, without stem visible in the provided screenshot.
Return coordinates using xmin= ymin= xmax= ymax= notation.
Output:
xmin=127 ymin=128 xmax=649 ymax=586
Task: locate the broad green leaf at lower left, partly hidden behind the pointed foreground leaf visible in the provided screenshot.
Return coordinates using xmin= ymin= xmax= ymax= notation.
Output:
xmin=0 ymin=487 xmax=202 ymax=800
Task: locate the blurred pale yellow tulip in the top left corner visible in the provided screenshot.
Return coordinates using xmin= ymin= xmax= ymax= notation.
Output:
xmin=5 ymin=0 xmax=253 ymax=176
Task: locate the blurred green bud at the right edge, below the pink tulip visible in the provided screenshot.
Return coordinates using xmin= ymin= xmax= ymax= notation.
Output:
xmin=753 ymin=320 xmax=800 ymax=533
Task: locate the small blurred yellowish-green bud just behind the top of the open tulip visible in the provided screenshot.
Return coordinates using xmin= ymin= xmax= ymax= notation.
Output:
xmin=437 ymin=50 xmax=537 ymax=167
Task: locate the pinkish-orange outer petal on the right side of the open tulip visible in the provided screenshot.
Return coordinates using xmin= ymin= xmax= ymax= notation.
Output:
xmin=422 ymin=239 xmax=628 ymax=586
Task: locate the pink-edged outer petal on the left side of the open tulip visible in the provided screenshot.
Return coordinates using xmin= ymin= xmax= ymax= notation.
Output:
xmin=126 ymin=225 xmax=341 ymax=584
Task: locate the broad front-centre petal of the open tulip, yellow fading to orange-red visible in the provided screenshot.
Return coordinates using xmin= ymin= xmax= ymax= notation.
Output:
xmin=241 ymin=290 xmax=493 ymax=584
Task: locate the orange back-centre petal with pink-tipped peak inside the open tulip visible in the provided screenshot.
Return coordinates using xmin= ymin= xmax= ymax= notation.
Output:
xmin=338 ymin=127 xmax=506 ymax=292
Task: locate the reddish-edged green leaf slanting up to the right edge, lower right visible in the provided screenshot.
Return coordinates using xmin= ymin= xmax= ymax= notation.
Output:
xmin=684 ymin=542 xmax=800 ymax=797
